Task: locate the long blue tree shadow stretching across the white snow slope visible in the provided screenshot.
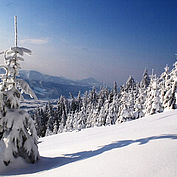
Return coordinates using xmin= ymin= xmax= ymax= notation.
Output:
xmin=0 ymin=134 xmax=177 ymax=175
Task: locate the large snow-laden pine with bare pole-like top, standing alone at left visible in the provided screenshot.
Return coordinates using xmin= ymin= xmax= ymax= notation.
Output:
xmin=0 ymin=17 xmax=39 ymax=166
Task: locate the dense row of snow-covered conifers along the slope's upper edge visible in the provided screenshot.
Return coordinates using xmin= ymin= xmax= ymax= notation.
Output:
xmin=32 ymin=62 xmax=177 ymax=137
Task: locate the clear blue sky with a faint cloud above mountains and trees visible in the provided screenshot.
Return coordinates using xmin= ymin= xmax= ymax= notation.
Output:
xmin=0 ymin=0 xmax=177 ymax=84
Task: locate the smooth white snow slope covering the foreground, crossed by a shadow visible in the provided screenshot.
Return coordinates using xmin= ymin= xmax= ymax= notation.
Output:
xmin=0 ymin=110 xmax=177 ymax=177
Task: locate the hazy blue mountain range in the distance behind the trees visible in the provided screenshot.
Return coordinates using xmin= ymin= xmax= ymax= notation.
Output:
xmin=19 ymin=70 xmax=101 ymax=99
